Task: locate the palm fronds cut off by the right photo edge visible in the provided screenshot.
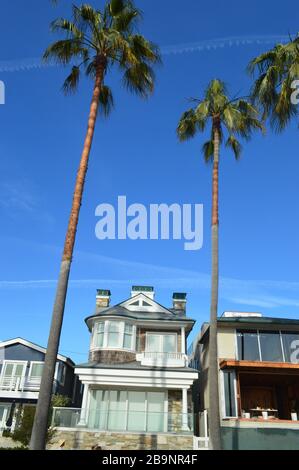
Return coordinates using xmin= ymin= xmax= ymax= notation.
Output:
xmin=248 ymin=35 xmax=299 ymax=132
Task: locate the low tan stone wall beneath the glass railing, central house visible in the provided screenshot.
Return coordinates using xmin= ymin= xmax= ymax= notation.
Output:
xmin=48 ymin=429 xmax=193 ymax=450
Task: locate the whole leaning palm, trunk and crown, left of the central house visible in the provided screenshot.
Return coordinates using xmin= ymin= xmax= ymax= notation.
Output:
xmin=30 ymin=0 xmax=160 ymax=450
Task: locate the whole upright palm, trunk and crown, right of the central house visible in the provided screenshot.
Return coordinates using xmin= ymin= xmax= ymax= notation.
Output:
xmin=177 ymin=80 xmax=262 ymax=450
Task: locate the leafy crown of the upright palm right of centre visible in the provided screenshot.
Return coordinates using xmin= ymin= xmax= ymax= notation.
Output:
xmin=177 ymin=80 xmax=262 ymax=161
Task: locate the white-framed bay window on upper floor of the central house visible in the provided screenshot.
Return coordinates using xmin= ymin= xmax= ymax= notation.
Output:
xmin=91 ymin=320 xmax=136 ymax=352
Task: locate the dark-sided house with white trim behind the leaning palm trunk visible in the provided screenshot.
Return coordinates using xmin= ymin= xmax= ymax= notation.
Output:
xmin=0 ymin=338 xmax=82 ymax=432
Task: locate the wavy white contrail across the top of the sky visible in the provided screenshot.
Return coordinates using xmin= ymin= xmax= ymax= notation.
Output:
xmin=0 ymin=35 xmax=289 ymax=73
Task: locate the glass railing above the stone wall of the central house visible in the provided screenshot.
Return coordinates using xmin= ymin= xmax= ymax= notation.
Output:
xmin=52 ymin=408 xmax=193 ymax=434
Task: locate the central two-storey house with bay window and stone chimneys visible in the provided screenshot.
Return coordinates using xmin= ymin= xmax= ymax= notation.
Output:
xmin=51 ymin=287 xmax=198 ymax=450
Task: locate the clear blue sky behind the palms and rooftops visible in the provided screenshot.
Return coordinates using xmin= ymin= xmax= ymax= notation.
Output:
xmin=0 ymin=0 xmax=299 ymax=362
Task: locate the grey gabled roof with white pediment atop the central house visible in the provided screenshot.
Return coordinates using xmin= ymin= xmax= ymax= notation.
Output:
xmin=85 ymin=293 xmax=195 ymax=329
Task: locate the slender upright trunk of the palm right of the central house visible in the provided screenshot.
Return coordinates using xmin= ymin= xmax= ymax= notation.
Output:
xmin=208 ymin=120 xmax=221 ymax=450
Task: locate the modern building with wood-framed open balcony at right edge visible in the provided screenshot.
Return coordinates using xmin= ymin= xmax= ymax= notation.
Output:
xmin=193 ymin=312 xmax=299 ymax=450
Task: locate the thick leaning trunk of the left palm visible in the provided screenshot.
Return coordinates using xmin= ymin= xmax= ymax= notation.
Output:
xmin=30 ymin=58 xmax=106 ymax=450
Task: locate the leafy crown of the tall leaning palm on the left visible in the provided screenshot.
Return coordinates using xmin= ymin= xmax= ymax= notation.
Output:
xmin=44 ymin=0 xmax=160 ymax=109
